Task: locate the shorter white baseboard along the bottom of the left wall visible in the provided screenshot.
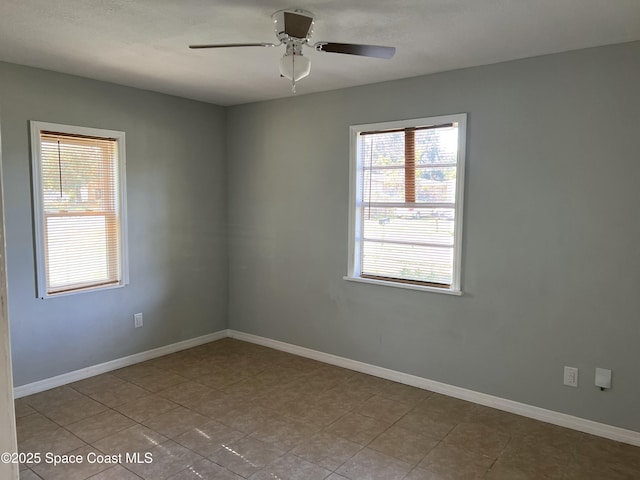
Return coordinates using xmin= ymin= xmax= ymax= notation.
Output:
xmin=13 ymin=330 xmax=228 ymax=398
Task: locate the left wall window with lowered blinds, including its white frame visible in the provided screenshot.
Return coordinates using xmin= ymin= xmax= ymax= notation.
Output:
xmin=31 ymin=122 xmax=128 ymax=298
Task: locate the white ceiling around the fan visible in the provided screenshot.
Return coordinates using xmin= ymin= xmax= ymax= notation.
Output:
xmin=0 ymin=0 xmax=640 ymax=105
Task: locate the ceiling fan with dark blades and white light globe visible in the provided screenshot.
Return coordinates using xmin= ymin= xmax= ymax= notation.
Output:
xmin=189 ymin=8 xmax=396 ymax=93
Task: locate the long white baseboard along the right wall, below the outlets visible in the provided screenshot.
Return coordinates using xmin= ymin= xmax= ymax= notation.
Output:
xmin=227 ymin=330 xmax=640 ymax=447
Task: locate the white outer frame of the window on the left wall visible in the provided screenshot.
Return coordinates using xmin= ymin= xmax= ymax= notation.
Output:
xmin=29 ymin=120 xmax=129 ymax=299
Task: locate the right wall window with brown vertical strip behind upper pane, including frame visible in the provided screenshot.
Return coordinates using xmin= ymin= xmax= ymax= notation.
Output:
xmin=345 ymin=114 xmax=466 ymax=294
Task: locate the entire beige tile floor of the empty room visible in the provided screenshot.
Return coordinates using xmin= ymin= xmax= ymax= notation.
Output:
xmin=16 ymin=339 xmax=640 ymax=480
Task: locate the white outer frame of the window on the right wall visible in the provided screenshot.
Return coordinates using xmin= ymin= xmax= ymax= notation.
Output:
xmin=343 ymin=113 xmax=467 ymax=296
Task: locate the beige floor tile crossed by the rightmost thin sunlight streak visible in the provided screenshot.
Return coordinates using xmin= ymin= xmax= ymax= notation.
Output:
xmin=209 ymin=437 xmax=284 ymax=478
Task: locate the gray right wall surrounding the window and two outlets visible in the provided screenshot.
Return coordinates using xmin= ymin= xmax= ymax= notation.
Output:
xmin=227 ymin=42 xmax=640 ymax=431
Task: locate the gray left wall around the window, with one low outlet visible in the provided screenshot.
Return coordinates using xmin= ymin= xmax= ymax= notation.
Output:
xmin=0 ymin=63 xmax=228 ymax=386
